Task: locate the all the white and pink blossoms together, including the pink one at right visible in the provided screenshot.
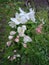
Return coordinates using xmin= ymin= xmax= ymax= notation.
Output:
xmin=6 ymin=8 xmax=43 ymax=61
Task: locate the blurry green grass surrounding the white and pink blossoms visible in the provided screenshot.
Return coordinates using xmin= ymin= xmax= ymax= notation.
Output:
xmin=0 ymin=2 xmax=49 ymax=65
